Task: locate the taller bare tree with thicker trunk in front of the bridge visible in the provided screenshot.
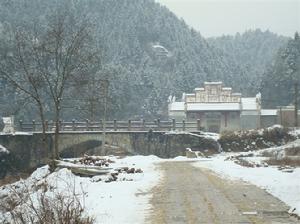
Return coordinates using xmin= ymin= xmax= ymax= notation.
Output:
xmin=35 ymin=13 xmax=100 ymax=158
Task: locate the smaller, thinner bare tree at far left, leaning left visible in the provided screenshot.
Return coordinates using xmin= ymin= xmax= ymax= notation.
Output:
xmin=0 ymin=25 xmax=46 ymax=136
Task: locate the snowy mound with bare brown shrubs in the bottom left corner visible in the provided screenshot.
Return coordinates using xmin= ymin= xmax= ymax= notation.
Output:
xmin=0 ymin=166 xmax=94 ymax=224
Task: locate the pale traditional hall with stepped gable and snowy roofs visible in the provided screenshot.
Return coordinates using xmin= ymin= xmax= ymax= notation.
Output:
xmin=168 ymin=82 xmax=277 ymax=132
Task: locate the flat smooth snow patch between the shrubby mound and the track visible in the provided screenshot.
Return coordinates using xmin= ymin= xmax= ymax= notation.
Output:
xmin=79 ymin=156 xmax=159 ymax=223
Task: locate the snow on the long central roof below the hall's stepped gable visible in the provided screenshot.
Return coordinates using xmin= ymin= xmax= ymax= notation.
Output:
xmin=187 ymin=103 xmax=240 ymax=111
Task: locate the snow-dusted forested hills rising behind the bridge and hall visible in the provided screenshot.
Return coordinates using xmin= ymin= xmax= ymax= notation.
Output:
xmin=0 ymin=0 xmax=290 ymax=119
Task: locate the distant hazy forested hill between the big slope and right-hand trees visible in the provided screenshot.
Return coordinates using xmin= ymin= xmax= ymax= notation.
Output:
xmin=207 ymin=29 xmax=288 ymax=94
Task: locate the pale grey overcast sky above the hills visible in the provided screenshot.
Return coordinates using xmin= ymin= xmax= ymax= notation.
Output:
xmin=156 ymin=0 xmax=300 ymax=37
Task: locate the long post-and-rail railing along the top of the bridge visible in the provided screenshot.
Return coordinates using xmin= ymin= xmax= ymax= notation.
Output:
xmin=19 ymin=119 xmax=202 ymax=132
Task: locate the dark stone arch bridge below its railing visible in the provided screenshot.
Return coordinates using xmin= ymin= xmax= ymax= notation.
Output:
xmin=0 ymin=131 xmax=219 ymax=170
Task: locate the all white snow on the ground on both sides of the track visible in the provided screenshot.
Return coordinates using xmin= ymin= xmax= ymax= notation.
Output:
xmin=0 ymin=136 xmax=300 ymax=224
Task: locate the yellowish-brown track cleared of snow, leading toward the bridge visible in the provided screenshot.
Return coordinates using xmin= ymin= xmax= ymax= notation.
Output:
xmin=147 ymin=162 xmax=299 ymax=224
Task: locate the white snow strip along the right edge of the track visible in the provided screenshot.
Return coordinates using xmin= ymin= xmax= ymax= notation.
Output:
xmin=194 ymin=153 xmax=300 ymax=215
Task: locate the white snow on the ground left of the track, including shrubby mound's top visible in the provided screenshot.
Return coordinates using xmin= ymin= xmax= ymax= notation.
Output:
xmin=0 ymin=156 xmax=161 ymax=224
